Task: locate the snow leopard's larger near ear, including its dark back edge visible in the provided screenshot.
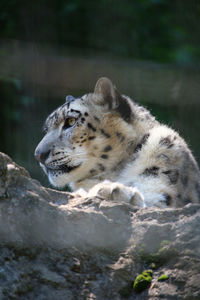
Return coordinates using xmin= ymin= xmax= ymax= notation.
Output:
xmin=94 ymin=77 xmax=133 ymax=122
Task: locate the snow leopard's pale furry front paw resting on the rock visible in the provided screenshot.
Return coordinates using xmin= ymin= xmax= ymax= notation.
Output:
xmin=89 ymin=180 xmax=144 ymax=207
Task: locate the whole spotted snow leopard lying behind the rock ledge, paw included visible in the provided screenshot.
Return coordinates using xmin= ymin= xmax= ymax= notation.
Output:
xmin=35 ymin=78 xmax=200 ymax=207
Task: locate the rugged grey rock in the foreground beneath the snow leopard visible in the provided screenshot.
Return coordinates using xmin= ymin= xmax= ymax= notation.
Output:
xmin=0 ymin=153 xmax=200 ymax=300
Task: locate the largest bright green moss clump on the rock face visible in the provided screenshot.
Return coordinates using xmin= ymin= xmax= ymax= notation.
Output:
xmin=133 ymin=270 xmax=153 ymax=293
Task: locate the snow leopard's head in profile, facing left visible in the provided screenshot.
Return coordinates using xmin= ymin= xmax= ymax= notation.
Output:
xmin=35 ymin=78 xmax=133 ymax=187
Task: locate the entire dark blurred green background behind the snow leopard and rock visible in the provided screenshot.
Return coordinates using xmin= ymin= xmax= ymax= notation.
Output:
xmin=0 ymin=0 xmax=200 ymax=186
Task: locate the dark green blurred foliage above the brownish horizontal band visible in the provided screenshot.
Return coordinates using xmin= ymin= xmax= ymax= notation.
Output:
xmin=0 ymin=0 xmax=200 ymax=64
